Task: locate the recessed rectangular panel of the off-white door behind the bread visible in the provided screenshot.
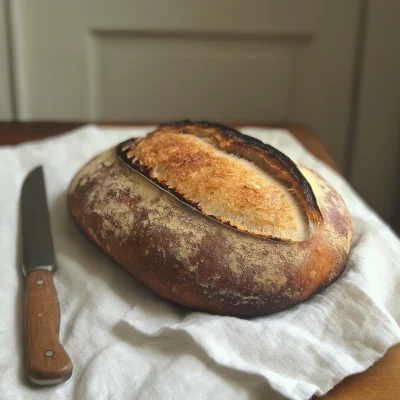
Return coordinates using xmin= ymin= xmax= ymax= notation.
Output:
xmin=89 ymin=31 xmax=309 ymax=121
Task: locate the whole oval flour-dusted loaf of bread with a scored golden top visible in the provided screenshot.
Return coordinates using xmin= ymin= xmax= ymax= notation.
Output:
xmin=68 ymin=121 xmax=352 ymax=317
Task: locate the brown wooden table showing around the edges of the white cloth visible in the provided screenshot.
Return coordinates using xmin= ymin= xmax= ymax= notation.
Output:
xmin=0 ymin=122 xmax=400 ymax=400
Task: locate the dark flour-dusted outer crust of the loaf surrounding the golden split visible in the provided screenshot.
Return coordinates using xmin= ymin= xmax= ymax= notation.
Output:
xmin=68 ymin=121 xmax=352 ymax=317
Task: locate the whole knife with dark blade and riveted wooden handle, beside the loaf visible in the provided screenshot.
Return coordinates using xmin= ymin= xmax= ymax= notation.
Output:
xmin=21 ymin=166 xmax=72 ymax=385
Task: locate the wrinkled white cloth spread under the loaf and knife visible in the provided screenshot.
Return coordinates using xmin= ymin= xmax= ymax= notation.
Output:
xmin=0 ymin=125 xmax=400 ymax=400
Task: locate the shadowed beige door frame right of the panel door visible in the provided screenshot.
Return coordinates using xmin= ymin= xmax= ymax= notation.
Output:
xmin=348 ymin=0 xmax=400 ymax=223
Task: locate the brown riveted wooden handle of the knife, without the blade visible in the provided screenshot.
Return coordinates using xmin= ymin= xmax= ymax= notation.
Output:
xmin=25 ymin=270 xmax=72 ymax=385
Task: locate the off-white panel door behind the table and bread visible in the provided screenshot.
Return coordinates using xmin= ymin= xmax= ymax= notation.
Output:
xmin=11 ymin=0 xmax=360 ymax=164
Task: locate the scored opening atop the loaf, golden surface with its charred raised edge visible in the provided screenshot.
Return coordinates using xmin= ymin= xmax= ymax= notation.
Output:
xmin=119 ymin=122 xmax=322 ymax=241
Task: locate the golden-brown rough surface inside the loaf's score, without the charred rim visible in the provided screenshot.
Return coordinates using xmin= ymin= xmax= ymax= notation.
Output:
xmin=130 ymin=132 xmax=308 ymax=237
